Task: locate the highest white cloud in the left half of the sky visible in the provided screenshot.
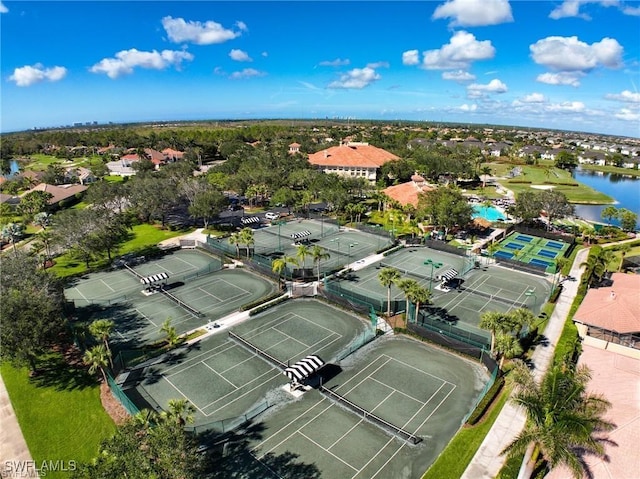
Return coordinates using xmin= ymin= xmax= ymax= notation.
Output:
xmin=162 ymin=17 xmax=247 ymax=45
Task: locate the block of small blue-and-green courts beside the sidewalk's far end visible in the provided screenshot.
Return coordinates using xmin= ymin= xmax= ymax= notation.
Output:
xmin=494 ymin=232 xmax=569 ymax=273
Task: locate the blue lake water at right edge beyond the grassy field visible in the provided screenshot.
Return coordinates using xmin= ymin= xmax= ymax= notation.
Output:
xmin=572 ymin=169 xmax=640 ymax=227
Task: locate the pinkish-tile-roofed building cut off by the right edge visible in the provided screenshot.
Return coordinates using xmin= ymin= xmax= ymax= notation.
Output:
xmin=573 ymin=273 xmax=640 ymax=357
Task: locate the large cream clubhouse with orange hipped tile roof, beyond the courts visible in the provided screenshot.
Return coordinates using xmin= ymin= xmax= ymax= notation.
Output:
xmin=309 ymin=142 xmax=400 ymax=183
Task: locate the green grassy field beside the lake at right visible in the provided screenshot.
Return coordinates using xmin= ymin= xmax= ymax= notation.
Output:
xmin=487 ymin=163 xmax=613 ymax=204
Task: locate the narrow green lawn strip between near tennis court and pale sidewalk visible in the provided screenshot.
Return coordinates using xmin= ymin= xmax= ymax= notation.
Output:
xmin=422 ymin=388 xmax=509 ymax=479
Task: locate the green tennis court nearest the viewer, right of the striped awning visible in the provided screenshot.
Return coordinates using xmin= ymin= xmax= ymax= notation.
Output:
xmin=234 ymin=337 xmax=488 ymax=479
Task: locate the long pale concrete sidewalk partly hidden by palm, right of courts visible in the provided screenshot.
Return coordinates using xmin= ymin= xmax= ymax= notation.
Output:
xmin=462 ymin=248 xmax=589 ymax=479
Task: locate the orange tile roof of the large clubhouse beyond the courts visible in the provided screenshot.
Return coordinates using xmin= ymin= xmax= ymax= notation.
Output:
xmin=309 ymin=143 xmax=400 ymax=168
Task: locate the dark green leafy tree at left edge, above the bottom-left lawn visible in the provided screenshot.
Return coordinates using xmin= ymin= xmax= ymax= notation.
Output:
xmin=0 ymin=253 xmax=65 ymax=372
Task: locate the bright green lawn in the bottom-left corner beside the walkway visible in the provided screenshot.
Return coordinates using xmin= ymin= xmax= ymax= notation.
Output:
xmin=0 ymin=357 xmax=115 ymax=478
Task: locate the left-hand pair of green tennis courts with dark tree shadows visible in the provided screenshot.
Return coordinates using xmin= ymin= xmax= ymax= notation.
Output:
xmin=65 ymin=251 xmax=276 ymax=350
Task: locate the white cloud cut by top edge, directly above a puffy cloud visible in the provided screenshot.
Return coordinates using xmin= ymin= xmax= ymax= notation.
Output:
xmin=431 ymin=0 xmax=513 ymax=27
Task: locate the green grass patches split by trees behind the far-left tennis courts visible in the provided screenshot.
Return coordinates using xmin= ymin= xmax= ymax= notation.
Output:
xmin=50 ymin=224 xmax=188 ymax=278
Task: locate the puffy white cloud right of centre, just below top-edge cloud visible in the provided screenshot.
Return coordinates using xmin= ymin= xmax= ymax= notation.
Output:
xmin=422 ymin=30 xmax=496 ymax=70
